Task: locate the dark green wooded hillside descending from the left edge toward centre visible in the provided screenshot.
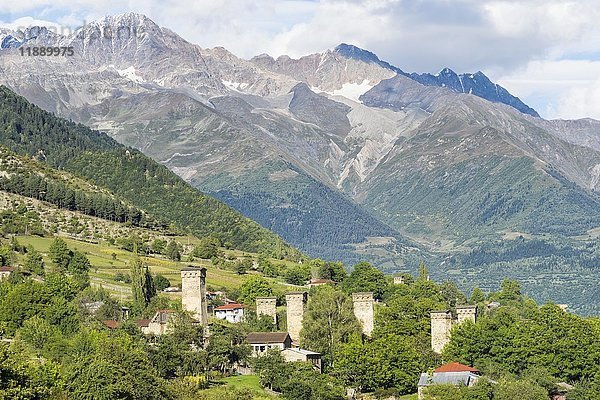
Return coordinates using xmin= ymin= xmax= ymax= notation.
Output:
xmin=0 ymin=87 xmax=298 ymax=256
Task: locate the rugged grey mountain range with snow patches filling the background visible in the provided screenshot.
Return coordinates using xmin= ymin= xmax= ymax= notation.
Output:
xmin=0 ymin=14 xmax=600 ymax=312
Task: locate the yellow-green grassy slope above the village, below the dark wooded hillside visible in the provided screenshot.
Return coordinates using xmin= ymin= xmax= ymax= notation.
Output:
xmin=0 ymin=191 xmax=304 ymax=297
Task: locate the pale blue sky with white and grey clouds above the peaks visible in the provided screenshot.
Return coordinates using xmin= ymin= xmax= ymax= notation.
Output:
xmin=0 ymin=0 xmax=600 ymax=119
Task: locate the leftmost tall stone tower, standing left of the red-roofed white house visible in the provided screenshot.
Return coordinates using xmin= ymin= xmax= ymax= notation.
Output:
xmin=181 ymin=267 xmax=208 ymax=326
